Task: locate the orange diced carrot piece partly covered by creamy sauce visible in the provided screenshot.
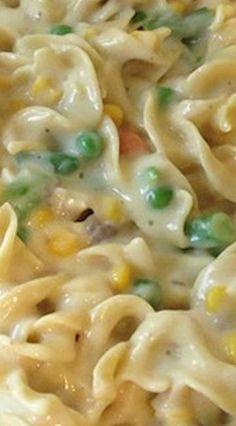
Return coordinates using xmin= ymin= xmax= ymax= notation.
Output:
xmin=119 ymin=127 xmax=150 ymax=155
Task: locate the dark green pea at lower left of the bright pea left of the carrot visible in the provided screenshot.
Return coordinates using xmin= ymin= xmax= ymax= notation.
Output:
xmin=49 ymin=152 xmax=79 ymax=176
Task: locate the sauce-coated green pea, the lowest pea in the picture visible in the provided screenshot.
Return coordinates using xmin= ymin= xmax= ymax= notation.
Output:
xmin=132 ymin=278 xmax=161 ymax=309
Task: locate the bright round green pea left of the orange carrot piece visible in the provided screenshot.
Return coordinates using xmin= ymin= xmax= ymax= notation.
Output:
xmin=75 ymin=131 xmax=104 ymax=160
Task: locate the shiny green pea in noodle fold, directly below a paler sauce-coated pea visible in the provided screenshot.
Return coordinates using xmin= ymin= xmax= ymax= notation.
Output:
xmin=146 ymin=186 xmax=174 ymax=210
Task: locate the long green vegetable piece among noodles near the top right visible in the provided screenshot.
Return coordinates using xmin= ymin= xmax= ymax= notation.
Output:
xmin=143 ymin=7 xmax=214 ymax=40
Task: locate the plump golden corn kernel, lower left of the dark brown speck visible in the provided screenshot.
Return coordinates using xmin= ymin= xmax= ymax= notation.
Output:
xmin=48 ymin=229 xmax=79 ymax=257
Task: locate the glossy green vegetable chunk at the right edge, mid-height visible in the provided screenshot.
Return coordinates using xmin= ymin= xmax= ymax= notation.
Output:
xmin=185 ymin=213 xmax=236 ymax=249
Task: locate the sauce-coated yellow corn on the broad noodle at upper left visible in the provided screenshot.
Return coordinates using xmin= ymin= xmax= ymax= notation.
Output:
xmin=31 ymin=77 xmax=62 ymax=104
